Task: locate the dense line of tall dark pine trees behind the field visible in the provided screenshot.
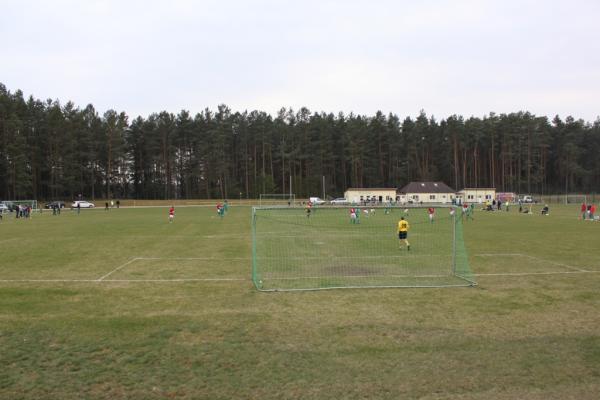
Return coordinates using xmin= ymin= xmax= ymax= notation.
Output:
xmin=0 ymin=84 xmax=600 ymax=199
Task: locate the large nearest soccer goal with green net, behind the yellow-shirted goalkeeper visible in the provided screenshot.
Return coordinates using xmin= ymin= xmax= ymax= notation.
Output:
xmin=252 ymin=207 xmax=475 ymax=291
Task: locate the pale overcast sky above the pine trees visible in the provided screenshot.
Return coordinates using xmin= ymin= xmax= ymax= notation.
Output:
xmin=0 ymin=0 xmax=600 ymax=122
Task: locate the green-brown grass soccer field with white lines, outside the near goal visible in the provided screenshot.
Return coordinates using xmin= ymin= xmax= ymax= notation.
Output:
xmin=0 ymin=206 xmax=600 ymax=400
